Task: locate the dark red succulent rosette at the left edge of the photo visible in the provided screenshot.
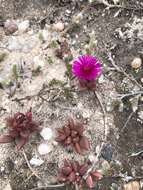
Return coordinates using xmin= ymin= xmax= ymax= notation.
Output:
xmin=0 ymin=112 xmax=39 ymax=150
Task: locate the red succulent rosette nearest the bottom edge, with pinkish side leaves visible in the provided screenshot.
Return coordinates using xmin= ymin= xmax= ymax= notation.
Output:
xmin=58 ymin=159 xmax=103 ymax=188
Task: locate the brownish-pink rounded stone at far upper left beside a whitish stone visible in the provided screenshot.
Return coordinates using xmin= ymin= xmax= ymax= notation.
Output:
xmin=4 ymin=20 xmax=18 ymax=35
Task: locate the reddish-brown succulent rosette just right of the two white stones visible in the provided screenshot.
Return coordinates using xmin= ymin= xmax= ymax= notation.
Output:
xmin=56 ymin=119 xmax=90 ymax=154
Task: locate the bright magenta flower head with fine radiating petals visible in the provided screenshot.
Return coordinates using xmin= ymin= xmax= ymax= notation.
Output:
xmin=72 ymin=55 xmax=101 ymax=81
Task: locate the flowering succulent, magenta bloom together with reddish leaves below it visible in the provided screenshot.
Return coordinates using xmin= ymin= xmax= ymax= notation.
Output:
xmin=72 ymin=55 xmax=101 ymax=90
